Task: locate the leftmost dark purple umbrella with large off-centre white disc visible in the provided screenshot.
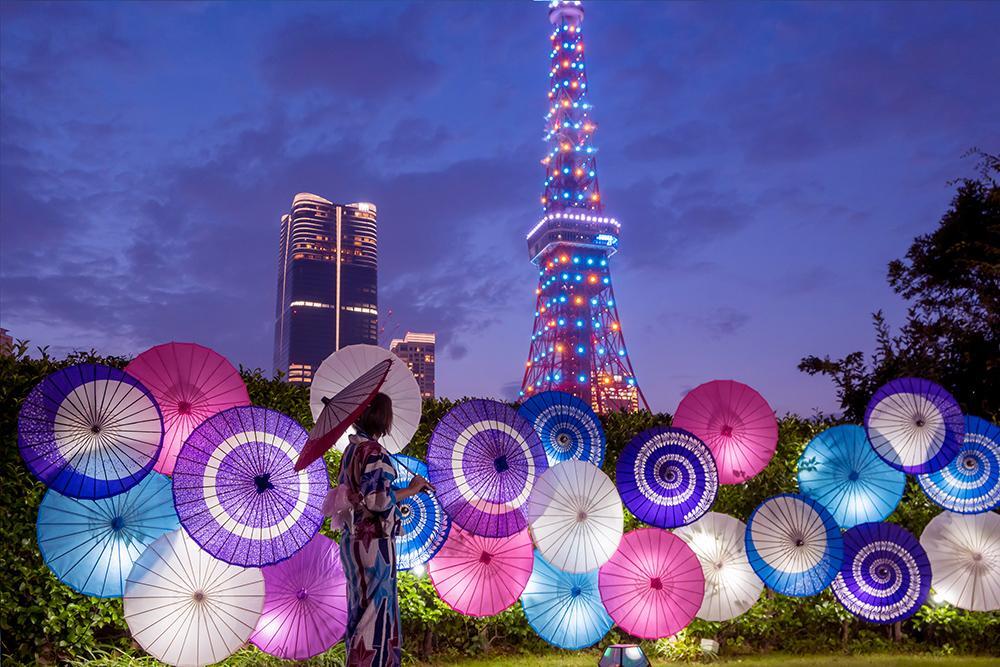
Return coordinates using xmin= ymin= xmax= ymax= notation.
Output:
xmin=17 ymin=364 xmax=163 ymax=498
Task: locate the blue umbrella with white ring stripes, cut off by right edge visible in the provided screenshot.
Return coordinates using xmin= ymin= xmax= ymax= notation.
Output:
xmin=917 ymin=417 xmax=1000 ymax=514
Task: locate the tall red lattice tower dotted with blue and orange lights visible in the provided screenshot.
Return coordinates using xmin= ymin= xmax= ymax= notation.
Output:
xmin=521 ymin=0 xmax=648 ymax=412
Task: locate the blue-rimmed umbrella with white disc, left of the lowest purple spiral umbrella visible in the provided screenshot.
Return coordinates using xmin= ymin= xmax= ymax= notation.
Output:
xmin=746 ymin=493 xmax=844 ymax=597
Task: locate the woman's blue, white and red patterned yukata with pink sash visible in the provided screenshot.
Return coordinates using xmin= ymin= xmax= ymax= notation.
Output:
xmin=337 ymin=434 xmax=402 ymax=667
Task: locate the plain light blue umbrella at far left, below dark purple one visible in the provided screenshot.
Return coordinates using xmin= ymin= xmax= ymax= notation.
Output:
xmin=38 ymin=472 xmax=180 ymax=598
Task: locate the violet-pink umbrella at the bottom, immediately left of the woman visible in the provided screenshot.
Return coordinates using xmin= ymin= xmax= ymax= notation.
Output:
xmin=250 ymin=535 xmax=347 ymax=660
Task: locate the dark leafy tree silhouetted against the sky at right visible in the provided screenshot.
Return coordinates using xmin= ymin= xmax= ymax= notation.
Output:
xmin=799 ymin=150 xmax=1000 ymax=421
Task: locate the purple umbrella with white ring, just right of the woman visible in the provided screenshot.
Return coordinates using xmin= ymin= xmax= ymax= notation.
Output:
xmin=427 ymin=400 xmax=548 ymax=537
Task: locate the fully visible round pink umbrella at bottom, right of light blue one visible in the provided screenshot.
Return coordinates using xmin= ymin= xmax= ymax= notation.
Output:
xmin=598 ymin=528 xmax=705 ymax=639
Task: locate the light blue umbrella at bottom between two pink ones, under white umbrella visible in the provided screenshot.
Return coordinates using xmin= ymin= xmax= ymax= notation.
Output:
xmin=521 ymin=551 xmax=614 ymax=650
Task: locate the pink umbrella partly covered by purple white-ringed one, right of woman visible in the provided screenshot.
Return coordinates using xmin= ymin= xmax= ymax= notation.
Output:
xmin=428 ymin=524 xmax=535 ymax=616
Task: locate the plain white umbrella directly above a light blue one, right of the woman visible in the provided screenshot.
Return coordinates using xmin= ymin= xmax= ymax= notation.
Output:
xmin=528 ymin=461 xmax=625 ymax=576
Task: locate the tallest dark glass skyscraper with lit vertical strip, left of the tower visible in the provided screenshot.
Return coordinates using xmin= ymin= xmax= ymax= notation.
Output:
xmin=274 ymin=192 xmax=378 ymax=384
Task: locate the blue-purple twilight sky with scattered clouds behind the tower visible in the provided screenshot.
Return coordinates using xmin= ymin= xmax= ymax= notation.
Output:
xmin=0 ymin=0 xmax=1000 ymax=413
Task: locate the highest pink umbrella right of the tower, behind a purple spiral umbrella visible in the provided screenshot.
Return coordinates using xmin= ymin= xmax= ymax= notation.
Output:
xmin=671 ymin=380 xmax=778 ymax=484
